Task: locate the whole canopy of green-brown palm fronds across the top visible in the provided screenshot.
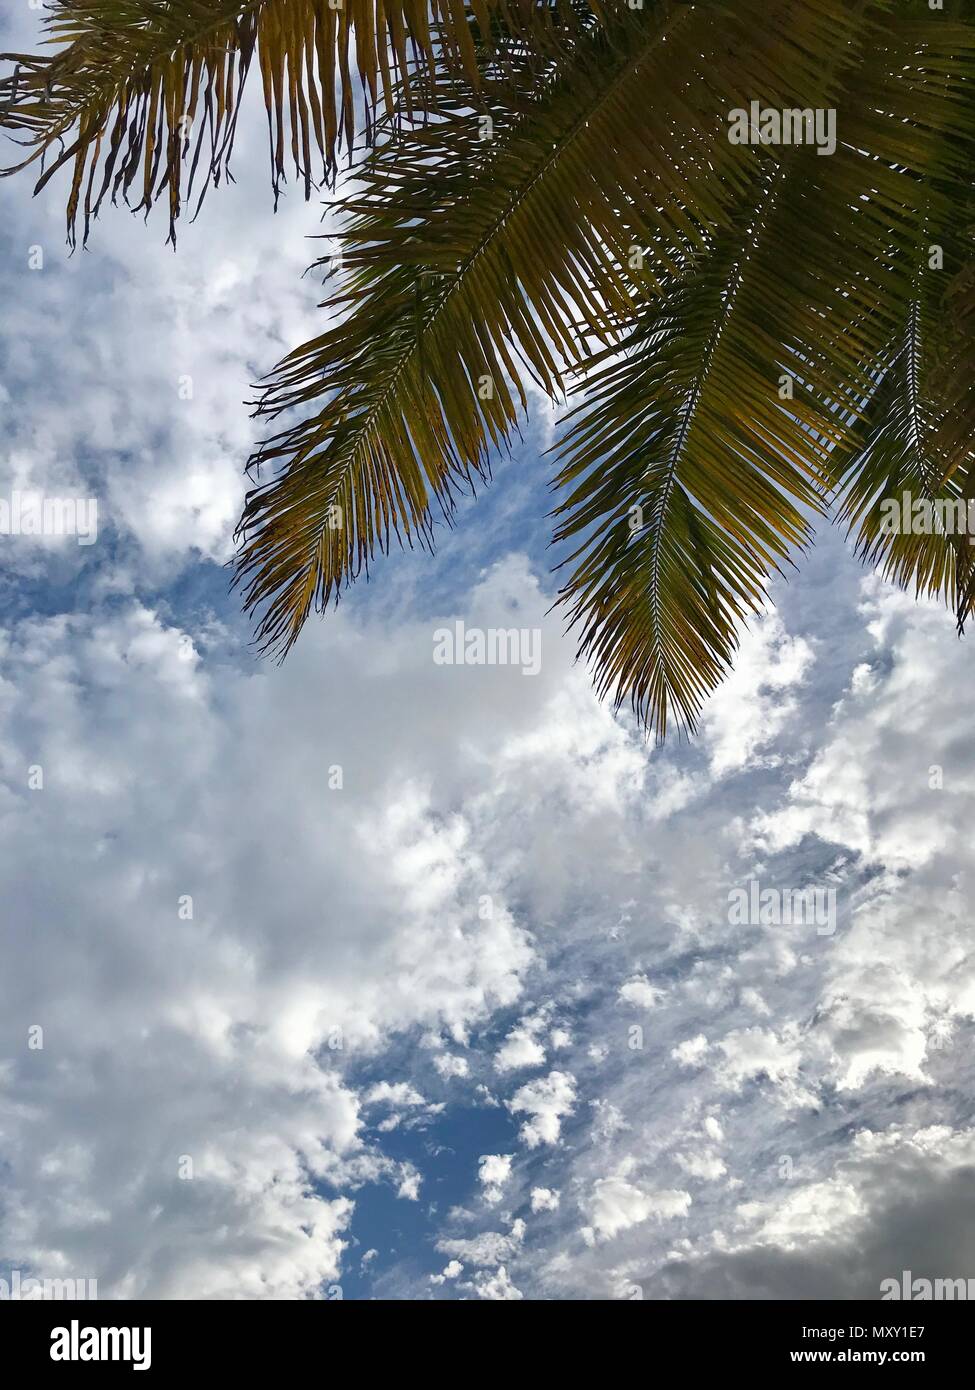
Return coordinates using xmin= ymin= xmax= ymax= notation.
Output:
xmin=0 ymin=0 xmax=975 ymax=735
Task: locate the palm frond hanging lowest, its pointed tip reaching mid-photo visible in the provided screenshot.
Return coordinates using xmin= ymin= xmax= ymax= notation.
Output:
xmin=556 ymin=0 xmax=972 ymax=735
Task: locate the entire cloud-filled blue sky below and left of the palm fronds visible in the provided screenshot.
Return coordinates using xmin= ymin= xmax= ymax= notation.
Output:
xmin=0 ymin=2 xmax=975 ymax=1300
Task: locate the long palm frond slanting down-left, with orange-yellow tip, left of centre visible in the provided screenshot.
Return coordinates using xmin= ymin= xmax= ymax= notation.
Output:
xmin=236 ymin=0 xmax=867 ymax=651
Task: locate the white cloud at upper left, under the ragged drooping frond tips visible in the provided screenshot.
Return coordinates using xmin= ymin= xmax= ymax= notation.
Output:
xmin=0 ymin=7 xmax=329 ymax=581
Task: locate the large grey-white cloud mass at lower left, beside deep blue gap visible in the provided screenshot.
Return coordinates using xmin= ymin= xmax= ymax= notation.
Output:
xmin=0 ymin=560 xmax=659 ymax=1297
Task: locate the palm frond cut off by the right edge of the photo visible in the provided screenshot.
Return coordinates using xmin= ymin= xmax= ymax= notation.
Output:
xmin=830 ymin=7 xmax=975 ymax=626
